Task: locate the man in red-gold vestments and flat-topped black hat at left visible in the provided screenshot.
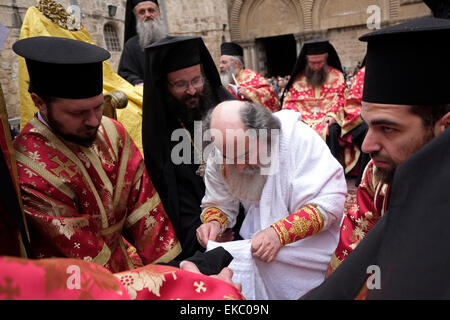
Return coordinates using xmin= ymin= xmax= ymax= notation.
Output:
xmin=13 ymin=37 xmax=185 ymax=272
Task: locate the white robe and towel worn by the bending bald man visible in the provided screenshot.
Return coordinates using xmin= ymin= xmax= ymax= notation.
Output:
xmin=202 ymin=110 xmax=347 ymax=300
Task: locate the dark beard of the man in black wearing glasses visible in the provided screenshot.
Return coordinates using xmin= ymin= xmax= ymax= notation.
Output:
xmin=164 ymin=79 xmax=215 ymax=127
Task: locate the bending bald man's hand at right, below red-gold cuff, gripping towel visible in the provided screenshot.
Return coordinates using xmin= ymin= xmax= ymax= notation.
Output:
xmin=252 ymin=227 xmax=281 ymax=263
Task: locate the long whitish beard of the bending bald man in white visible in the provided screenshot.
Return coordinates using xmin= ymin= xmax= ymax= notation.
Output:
xmin=225 ymin=164 xmax=267 ymax=203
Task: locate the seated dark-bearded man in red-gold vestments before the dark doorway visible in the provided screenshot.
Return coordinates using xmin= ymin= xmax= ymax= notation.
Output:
xmin=281 ymin=39 xmax=362 ymax=175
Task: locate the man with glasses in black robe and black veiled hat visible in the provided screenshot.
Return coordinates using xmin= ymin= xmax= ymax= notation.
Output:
xmin=142 ymin=37 xmax=239 ymax=259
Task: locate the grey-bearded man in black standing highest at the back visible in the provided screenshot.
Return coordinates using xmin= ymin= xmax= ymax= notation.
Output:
xmin=117 ymin=0 xmax=167 ymax=86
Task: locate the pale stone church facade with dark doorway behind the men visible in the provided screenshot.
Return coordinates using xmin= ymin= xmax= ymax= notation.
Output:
xmin=0 ymin=0 xmax=431 ymax=118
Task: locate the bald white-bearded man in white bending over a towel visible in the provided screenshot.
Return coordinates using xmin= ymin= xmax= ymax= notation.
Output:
xmin=197 ymin=101 xmax=347 ymax=300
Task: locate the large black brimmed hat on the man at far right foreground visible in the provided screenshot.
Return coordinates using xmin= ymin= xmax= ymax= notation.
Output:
xmin=360 ymin=17 xmax=450 ymax=105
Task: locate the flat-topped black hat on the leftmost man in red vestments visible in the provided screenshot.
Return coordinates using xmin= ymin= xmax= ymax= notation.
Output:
xmin=13 ymin=37 xmax=111 ymax=99
